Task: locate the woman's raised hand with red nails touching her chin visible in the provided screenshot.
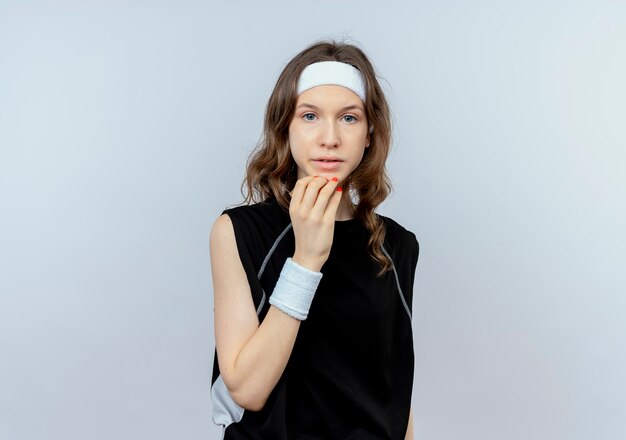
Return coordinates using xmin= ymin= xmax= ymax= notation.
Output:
xmin=289 ymin=176 xmax=342 ymax=272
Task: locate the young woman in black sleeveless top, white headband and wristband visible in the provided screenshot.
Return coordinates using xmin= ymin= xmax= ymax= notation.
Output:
xmin=210 ymin=42 xmax=419 ymax=440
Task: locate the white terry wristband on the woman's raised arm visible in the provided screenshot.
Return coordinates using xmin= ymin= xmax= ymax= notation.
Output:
xmin=270 ymin=258 xmax=322 ymax=321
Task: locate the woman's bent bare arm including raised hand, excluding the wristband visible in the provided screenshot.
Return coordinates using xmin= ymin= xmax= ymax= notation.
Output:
xmin=210 ymin=177 xmax=341 ymax=410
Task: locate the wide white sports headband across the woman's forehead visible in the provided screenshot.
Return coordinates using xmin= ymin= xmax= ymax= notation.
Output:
xmin=298 ymin=61 xmax=365 ymax=102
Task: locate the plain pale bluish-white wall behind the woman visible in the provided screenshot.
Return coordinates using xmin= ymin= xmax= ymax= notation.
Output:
xmin=0 ymin=0 xmax=626 ymax=440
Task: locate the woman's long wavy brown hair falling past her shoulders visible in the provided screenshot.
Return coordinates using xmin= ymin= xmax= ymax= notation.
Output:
xmin=242 ymin=41 xmax=392 ymax=276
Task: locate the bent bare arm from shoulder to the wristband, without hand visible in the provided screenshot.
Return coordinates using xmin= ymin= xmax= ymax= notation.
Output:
xmin=210 ymin=215 xmax=300 ymax=410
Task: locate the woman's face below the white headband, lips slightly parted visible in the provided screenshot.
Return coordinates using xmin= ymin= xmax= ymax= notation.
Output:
xmin=289 ymin=85 xmax=370 ymax=186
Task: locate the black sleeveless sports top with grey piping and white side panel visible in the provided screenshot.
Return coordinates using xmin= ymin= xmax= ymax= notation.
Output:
xmin=212 ymin=199 xmax=419 ymax=440
